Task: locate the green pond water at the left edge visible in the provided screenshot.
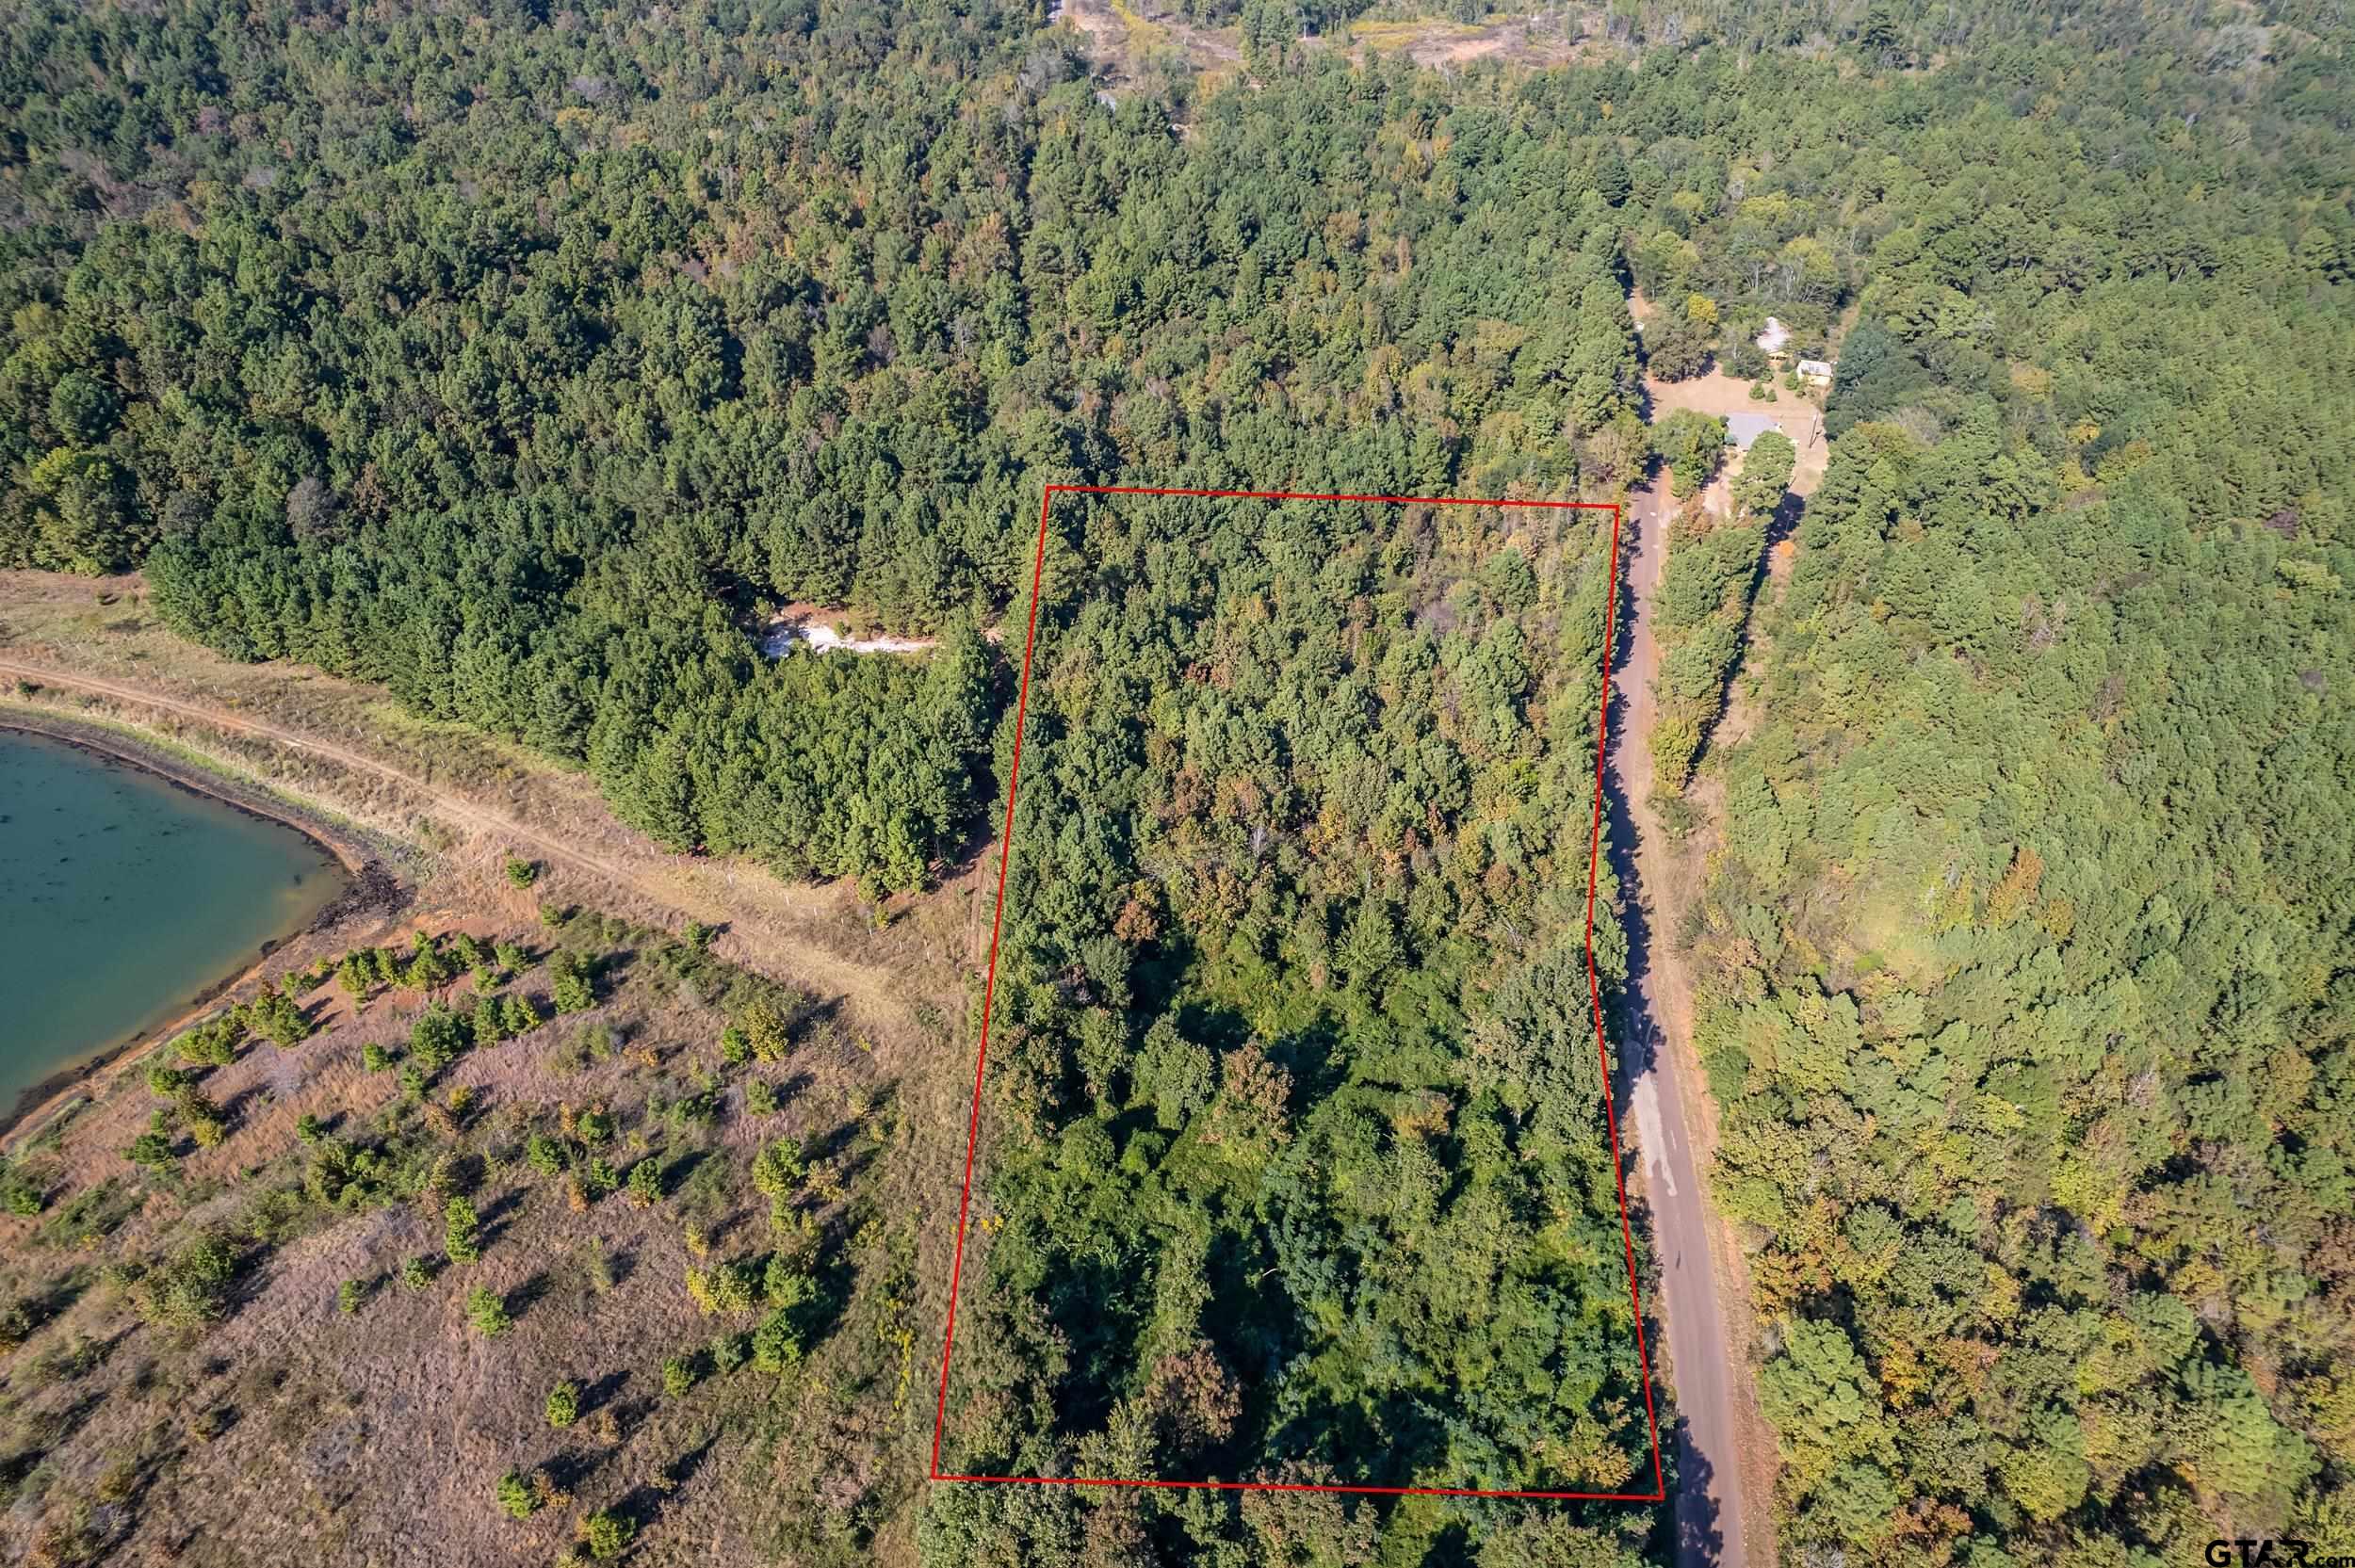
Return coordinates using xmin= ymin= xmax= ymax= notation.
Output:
xmin=0 ymin=730 xmax=347 ymax=1119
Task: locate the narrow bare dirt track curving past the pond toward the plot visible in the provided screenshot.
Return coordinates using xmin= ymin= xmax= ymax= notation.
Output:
xmin=0 ymin=657 xmax=912 ymax=1020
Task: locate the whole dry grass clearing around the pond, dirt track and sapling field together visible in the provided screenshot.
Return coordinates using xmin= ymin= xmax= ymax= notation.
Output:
xmin=0 ymin=573 xmax=997 ymax=1566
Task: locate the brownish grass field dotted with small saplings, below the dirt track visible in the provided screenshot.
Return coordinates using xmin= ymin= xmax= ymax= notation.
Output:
xmin=0 ymin=916 xmax=954 ymax=1568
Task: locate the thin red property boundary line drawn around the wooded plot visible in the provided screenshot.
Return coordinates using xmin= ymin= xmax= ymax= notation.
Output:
xmin=928 ymin=485 xmax=1667 ymax=1502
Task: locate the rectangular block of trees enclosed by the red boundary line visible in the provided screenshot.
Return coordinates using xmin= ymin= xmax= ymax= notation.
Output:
xmin=918 ymin=497 xmax=1656 ymax=1563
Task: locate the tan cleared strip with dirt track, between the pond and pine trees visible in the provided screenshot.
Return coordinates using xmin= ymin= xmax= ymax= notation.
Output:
xmin=0 ymin=573 xmax=975 ymax=1041
